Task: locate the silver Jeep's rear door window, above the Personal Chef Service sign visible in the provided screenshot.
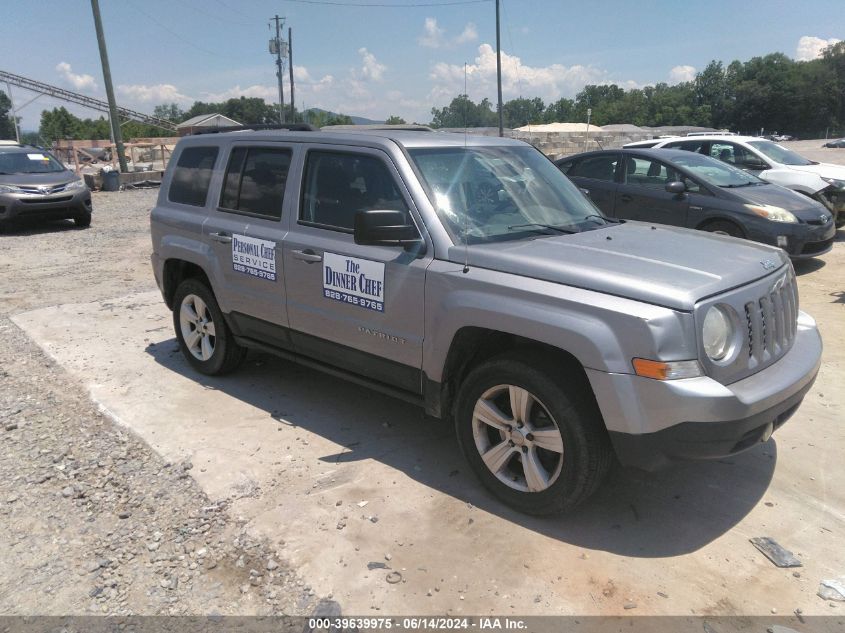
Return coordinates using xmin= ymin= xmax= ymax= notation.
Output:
xmin=220 ymin=147 xmax=291 ymax=220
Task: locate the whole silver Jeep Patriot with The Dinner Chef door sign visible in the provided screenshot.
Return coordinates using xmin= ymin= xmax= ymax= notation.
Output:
xmin=151 ymin=130 xmax=822 ymax=514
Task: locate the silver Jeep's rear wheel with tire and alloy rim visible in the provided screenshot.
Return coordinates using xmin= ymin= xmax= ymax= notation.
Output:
xmin=173 ymin=279 xmax=246 ymax=376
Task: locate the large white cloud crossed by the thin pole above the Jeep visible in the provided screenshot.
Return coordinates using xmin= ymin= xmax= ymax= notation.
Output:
xmin=429 ymin=44 xmax=612 ymax=101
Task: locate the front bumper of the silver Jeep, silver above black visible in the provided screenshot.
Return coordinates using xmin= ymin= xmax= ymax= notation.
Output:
xmin=587 ymin=312 xmax=822 ymax=470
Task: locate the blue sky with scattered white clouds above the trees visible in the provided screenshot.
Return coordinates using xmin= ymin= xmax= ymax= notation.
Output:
xmin=0 ymin=0 xmax=845 ymax=130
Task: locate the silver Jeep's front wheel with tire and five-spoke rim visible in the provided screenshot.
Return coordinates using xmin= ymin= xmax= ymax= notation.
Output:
xmin=455 ymin=355 xmax=613 ymax=515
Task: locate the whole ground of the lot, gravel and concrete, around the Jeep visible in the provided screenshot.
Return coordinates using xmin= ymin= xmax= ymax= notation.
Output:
xmin=0 ymin=142 xmax=845 ymax=615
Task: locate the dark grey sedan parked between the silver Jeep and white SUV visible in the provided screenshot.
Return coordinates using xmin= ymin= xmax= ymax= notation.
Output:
xmin=555 ymin=149 xmax=836 ymax=259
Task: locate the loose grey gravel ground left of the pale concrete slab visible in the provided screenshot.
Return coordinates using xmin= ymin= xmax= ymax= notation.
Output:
xmin=0 ymin=191 xmax=316 ymax=615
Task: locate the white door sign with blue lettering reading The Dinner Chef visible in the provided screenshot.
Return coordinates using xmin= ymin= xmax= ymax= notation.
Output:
xmin=323 ymin=253 xmax=384 ymax=312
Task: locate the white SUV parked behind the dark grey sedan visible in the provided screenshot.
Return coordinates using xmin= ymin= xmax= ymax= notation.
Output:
xmin=625 ymin=134 xmax=845 ymax=227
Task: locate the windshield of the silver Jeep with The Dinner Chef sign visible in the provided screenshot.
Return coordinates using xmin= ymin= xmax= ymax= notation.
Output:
xmin=409 ymin=146 xmax=609 ymax=244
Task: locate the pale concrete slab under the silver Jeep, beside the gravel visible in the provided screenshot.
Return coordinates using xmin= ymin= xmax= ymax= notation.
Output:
xmin=14 ymin=288 xmax=845 ymax=615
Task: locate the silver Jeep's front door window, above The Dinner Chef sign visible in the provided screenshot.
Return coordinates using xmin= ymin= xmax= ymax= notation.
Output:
xmin=299 ymin=151 xmax=410 ymax=232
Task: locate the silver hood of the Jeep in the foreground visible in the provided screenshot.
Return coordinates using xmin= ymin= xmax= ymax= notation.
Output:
xmin=449 ymin=222 xmax=789 ymax=311
